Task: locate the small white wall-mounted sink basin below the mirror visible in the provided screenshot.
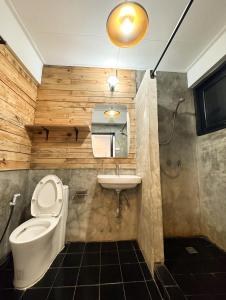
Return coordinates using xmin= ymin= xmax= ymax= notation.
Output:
xmin=97 ymin=175 xmax=141 ymax=191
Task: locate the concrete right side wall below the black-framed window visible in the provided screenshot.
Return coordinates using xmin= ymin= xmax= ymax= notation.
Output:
xmin=197 ymin=129 xmax=226 ymax=250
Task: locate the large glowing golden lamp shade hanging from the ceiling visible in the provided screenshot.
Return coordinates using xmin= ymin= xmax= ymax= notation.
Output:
xmin=107 ymin=1 xmax=149 ymax=48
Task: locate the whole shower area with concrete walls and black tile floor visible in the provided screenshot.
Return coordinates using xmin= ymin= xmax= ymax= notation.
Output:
xmin=156 ymin=72 xmax=226 ymax=300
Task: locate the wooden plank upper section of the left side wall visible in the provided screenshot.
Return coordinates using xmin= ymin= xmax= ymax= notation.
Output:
xmin=0 ymin=45 xmax=37 ymax=170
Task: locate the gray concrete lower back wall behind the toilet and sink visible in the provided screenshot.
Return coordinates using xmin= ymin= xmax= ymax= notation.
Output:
xmin=27 ymin=169 xmax=138 ymax=241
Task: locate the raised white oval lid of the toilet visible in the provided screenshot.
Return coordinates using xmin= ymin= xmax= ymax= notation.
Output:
xmin=31 ymin=175 xmax=63 ymax=217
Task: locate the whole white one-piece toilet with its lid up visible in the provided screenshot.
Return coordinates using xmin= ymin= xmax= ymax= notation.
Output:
xmin=9 ymin=175 xmax=69 ymax=289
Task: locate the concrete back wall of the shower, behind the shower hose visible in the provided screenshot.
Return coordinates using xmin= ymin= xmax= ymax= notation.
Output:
xmin=157 ymin=72 xmax=201 ymax=237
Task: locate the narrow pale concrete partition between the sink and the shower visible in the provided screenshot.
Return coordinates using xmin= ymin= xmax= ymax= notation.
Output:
xmin=135 ymin=71 xmax=164 ymax=270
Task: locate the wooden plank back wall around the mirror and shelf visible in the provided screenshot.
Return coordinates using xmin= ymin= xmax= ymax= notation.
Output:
xmin=31 ymin=66 xmax=136 ymax=169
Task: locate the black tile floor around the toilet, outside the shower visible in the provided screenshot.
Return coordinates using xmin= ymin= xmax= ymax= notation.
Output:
xmin=0 ymin=241 xmax=162 ymax=300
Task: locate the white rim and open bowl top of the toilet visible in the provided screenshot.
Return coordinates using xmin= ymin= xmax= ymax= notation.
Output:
xmin=10 ymin=218 xmax=59 ymax=245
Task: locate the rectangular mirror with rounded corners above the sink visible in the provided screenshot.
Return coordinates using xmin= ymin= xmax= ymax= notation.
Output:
xmin=92 ymin=104 xmax=129 ymax=157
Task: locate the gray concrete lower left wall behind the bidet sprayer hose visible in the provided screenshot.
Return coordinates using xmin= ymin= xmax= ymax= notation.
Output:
xmin=0 ymin=170 xmax=28 ymax=260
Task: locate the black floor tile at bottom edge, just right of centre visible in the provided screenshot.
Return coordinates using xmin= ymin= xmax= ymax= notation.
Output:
xmin=124 ymin=282 xmax=151 ymax=300
